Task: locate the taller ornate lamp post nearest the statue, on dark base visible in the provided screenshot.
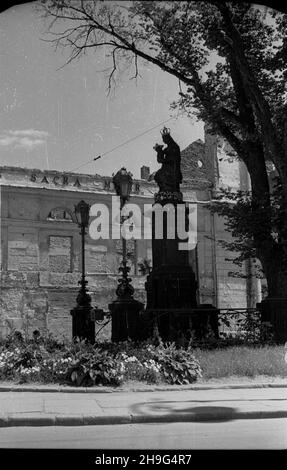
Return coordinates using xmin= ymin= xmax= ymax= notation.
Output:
xmin=109 ymin=168 xmax=144 ymax=341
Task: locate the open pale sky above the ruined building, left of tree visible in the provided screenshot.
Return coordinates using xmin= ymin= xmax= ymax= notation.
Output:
xmin=0 ymin=2 xmax=203 ymax=178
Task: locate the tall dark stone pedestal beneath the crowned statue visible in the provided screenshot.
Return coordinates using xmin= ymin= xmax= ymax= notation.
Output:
xmin=145 ymin=192 xmax=201 ymax=342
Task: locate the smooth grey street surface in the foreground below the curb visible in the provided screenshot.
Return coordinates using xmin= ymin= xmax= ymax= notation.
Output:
xmin=0 ymin=418 xmax=287 ymax=450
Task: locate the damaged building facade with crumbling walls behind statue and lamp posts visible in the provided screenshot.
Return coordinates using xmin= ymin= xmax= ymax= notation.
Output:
xmin=0 ymin=130 xmax=261 ymax=338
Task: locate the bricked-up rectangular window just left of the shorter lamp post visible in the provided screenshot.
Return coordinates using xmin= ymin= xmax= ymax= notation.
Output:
xmin=49 ymin=236 xmax=72 ymax=273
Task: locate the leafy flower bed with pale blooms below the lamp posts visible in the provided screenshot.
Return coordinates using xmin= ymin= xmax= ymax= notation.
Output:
xmin=0 ymin=336 xmax=202 ymax=386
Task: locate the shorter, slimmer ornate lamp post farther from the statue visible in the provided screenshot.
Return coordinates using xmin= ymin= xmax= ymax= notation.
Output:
xmin=71 ymin=200 xmax=95 ymax=343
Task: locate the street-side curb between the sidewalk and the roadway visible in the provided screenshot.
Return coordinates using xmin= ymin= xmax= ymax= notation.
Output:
xmin=0 ymin=410 xmax=287 ymax=428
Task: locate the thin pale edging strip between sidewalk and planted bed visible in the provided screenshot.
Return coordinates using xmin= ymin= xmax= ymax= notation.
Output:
xmin=0 ymin=381 xmax=287 ymax=393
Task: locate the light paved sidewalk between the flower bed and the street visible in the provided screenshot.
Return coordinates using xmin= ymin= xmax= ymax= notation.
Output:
xmin=0 ymin=381 xmax=287 ymax=427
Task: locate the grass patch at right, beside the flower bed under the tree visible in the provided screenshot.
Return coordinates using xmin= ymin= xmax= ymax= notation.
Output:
xmin=194 ymin=346 xmax=287 ymax=379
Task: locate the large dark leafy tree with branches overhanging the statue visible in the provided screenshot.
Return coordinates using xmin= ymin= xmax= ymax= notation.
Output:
xmin=43 ymin=0 xmax=287 ymax=296
